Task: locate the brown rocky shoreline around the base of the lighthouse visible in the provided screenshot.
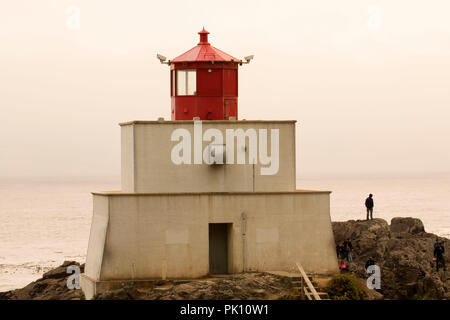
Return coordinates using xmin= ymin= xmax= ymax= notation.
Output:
xmin=0 ymin=218 xmax=450 ymax=300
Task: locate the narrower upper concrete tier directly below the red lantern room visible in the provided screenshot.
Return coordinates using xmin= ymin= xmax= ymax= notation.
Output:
xmin=121 ymin=121 xmax=296 ymax=192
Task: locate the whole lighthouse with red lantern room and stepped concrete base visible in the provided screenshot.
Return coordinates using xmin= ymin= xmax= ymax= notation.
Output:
xmin=81 ymin=29 xmax=338 ymax=299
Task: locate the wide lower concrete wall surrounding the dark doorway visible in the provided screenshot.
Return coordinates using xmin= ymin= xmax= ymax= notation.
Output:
xmin=85 ymin=191 xmax=337 ymax=280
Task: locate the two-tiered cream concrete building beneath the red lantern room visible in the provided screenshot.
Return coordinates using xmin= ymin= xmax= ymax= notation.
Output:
xmin=82 ymin=120 xmax=337 ymax=298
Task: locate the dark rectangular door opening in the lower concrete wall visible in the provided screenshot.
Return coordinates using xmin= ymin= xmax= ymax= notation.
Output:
xmin=209 ymin=223 xmax=229 ymax=274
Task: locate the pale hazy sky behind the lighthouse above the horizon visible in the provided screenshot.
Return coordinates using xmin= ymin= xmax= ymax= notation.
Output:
xmin=0 ymin=0 xmax=450 ymax=177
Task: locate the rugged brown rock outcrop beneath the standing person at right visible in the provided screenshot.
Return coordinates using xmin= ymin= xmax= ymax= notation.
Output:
xmin=332 ymin=218 xmax=450 ymax=299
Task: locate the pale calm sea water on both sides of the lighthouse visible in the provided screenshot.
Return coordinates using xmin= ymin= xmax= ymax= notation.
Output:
xmin=0 ymin=175 xmax=450 ymax=291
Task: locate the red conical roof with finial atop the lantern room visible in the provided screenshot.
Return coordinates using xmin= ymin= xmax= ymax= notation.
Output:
xmin=170 ymin=28 xmax=240 ymax=63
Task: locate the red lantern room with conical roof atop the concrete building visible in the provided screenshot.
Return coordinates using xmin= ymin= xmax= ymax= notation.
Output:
xmin=157 ymin=28 xmax=253 ymax=120
